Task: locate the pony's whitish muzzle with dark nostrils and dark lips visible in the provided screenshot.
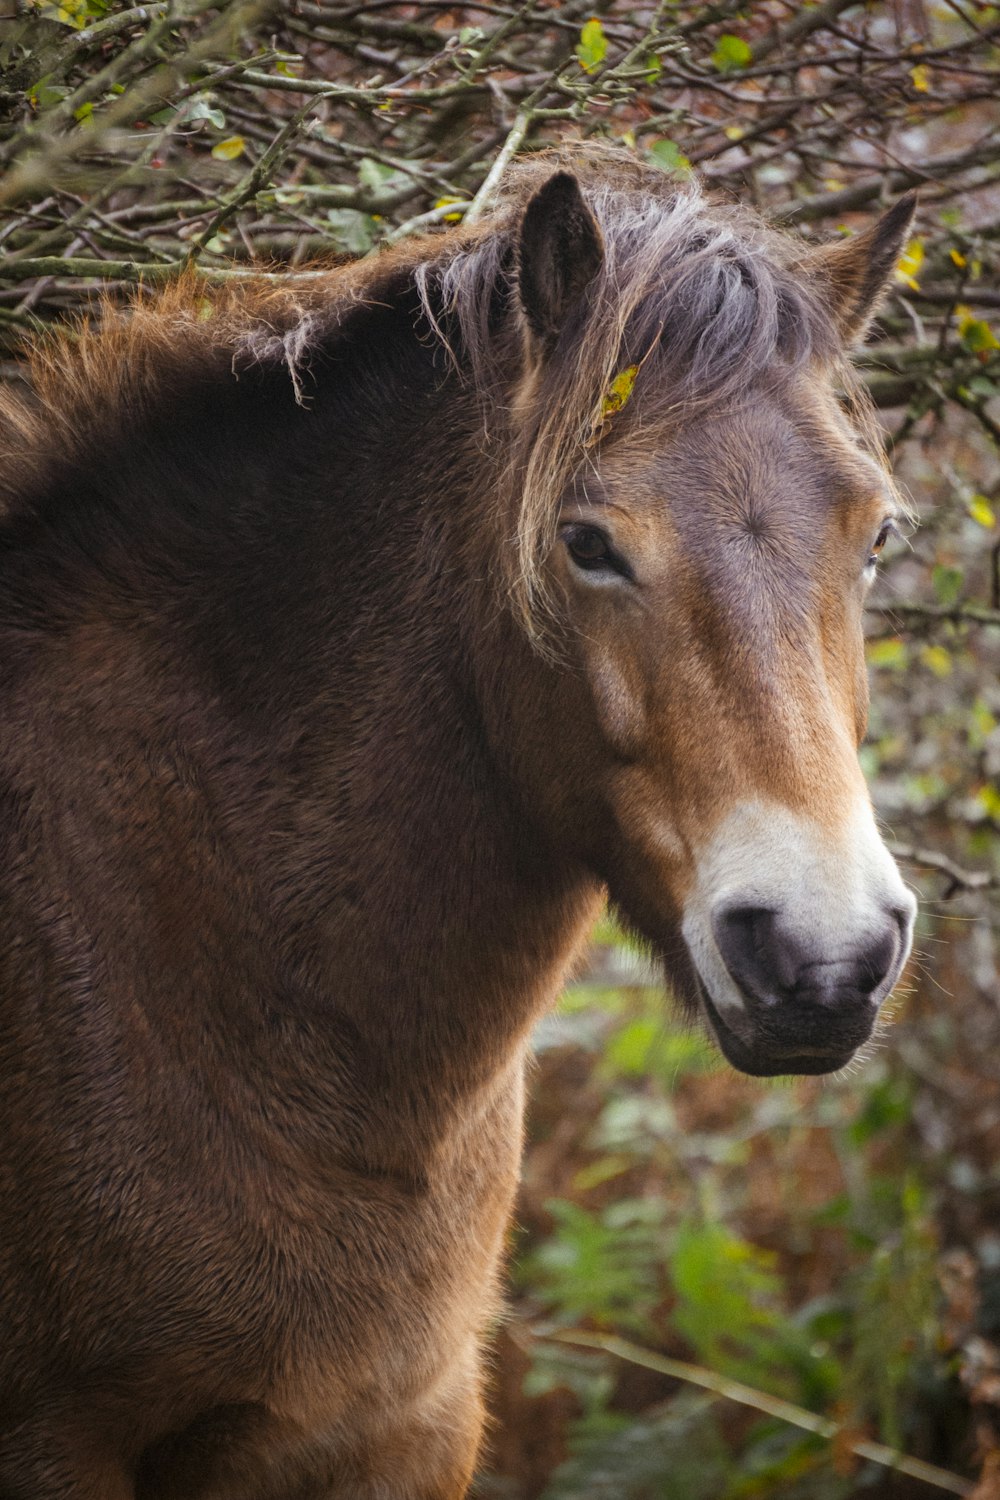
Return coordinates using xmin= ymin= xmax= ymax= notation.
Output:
xmin=682 ymin=804 xmax=916 ymax=1076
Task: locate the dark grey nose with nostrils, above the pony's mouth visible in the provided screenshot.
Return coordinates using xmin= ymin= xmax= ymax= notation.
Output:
xmin=712 ymin=906 xmax=910 ymax=1010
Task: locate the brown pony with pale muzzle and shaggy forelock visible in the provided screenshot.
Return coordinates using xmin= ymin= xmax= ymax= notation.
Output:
xmin=0 ymin=153 xmax=913 ymax=1500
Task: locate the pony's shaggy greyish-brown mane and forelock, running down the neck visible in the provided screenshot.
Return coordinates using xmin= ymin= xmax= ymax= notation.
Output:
xmin=0 ymin=146 xmax=868 ymax=636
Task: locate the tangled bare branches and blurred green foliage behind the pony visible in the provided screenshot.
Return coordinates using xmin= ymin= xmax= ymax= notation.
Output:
xmin=0 ymin=0 xmax=1000 ymax=1500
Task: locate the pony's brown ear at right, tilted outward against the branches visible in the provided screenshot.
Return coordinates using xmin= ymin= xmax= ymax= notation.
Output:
xmin=804 ymin=192 xmax=916 ymax=344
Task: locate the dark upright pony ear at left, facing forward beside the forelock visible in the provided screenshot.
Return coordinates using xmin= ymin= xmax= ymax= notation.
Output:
xmin=517 ymin=173 xmax=604 ymax=348
